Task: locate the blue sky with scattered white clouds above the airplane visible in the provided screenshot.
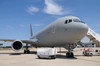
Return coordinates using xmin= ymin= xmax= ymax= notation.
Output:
xmin=0 ymin=0 xmax=100 ymax=46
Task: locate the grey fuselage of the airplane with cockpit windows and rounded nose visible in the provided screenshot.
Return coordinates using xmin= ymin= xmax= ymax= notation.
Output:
xmin=32 ymin=16 xmax=88 ymax=47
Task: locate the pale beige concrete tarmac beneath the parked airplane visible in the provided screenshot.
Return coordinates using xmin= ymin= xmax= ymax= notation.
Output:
xmin=0 ymin=49 xmax=100 ymax=66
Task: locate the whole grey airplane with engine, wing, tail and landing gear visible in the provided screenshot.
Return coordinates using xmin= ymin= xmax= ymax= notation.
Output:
xmin=0 ymin=16 xmax=88 ymax=57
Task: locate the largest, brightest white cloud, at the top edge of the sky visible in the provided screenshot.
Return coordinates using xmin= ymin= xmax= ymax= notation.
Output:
xmin=44 ymin=0 xmax=70 ymax=15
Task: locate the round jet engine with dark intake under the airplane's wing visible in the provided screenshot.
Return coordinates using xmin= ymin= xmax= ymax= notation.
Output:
xmin=11 ymin=40 xmax=23 ymax=51
